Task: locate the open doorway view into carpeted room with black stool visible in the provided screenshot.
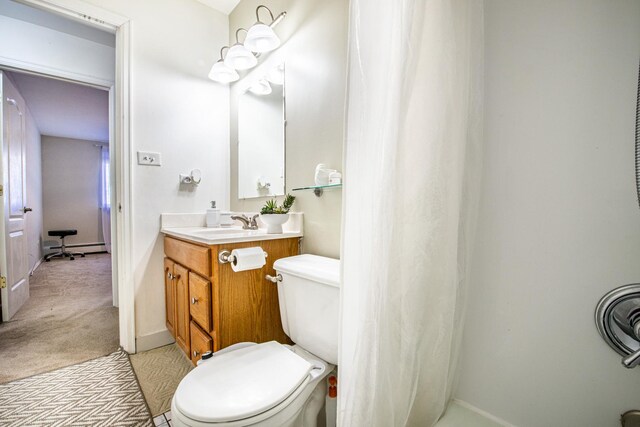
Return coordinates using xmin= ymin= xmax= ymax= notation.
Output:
xmin=0 ymin=64 xmax=119 ymax=383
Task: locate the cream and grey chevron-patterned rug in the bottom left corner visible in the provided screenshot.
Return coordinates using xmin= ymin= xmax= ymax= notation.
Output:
xmin=0 ymin=351 xmax=153 ymax=427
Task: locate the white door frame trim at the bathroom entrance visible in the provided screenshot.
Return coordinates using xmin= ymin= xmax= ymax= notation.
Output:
xmin=0 ymin=0 xmax=135 ymax=353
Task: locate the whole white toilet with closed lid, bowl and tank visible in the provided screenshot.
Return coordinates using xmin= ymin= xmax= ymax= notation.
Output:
xmin=171 ymin=255 xmax=340 ymax=427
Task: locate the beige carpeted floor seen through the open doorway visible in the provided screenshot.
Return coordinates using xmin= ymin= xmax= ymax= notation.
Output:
xmin=0 ymin=254 xmax=119 ymax=383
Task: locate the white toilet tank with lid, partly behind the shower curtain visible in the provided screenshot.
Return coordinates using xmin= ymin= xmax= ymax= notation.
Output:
xmin=273 ymin=255 xmax=340 ymax=364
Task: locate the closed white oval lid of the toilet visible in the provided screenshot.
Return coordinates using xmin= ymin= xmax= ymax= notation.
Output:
xmin=174 ymin=341 xmax=312 ymax=423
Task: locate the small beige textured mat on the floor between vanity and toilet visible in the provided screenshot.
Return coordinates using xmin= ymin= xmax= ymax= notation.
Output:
xmin=131 ymin=344 xmax=193 ymax=417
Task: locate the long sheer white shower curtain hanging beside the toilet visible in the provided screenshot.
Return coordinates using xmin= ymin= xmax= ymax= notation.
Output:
xmin=338 ymin=0 xmax=483 ymax=427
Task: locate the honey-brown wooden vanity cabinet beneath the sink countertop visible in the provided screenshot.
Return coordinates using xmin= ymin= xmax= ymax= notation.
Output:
xmin=164 ymin=236 xmax=299 ymax=364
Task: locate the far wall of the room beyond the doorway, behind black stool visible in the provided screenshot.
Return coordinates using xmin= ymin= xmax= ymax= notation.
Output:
xmin=42 ymin=135 xmax=104 ymax=251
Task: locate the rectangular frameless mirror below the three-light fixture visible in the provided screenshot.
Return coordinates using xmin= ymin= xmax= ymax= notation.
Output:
xmin=238 ymin=64 xmax=285 ymax=199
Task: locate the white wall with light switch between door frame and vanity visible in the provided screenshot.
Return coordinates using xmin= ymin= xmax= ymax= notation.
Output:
xmin=75 ymin=0 xmax=229 ymax=342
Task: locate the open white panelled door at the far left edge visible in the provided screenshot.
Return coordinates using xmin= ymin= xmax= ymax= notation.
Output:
xmin=0 ymin=72 xmax=29 ymax=321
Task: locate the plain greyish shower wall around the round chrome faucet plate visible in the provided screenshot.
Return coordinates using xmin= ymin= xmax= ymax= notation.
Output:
xmin=457 ymin=0 xmax=640 ymax=427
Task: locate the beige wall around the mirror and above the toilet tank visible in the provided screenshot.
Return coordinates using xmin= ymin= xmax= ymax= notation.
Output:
xmin=229 ymin=0 xmax=349 ymax=258
